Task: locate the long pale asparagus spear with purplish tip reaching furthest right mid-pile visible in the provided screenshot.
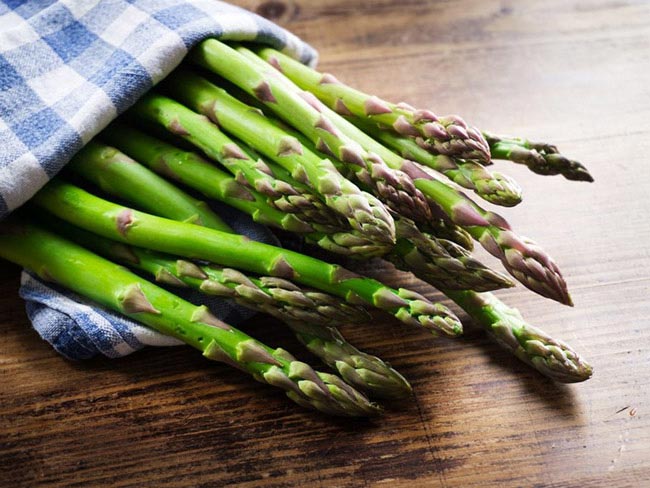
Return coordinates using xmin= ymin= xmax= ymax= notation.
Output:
xmin=232 ymin=51 xmax=572 ymax=305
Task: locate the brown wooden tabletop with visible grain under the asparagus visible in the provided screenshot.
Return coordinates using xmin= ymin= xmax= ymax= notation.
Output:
xmin=0 ymin=0 xmax=650 ymax=487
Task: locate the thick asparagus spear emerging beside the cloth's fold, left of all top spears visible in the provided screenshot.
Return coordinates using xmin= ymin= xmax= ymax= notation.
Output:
xmin=193 ymin=39 xmax=431 ymax=223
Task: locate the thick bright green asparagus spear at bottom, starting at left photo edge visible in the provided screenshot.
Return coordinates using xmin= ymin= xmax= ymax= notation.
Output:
xmin=0 ymin=217 xmax=381 ymax=417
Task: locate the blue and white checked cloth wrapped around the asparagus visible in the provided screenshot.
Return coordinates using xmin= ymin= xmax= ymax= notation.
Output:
xmin=0 ymin=0 xmax=316 ymax=359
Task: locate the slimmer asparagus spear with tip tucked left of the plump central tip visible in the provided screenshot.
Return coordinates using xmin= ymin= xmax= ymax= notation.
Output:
xmin=130 ymin=93 xmax=336 ymax=229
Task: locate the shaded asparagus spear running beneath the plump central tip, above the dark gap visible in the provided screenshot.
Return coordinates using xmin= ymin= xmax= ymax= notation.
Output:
xmin=101 ymin=124 xmax=391 ymax=257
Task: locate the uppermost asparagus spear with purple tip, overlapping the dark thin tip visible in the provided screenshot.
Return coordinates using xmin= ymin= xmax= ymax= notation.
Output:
xmin=257 ymin=48 xmax=490 ymax=161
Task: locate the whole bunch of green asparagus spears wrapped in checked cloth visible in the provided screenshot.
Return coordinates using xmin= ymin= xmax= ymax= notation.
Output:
xmin=0 ymin=39 xmax=592 ymax=416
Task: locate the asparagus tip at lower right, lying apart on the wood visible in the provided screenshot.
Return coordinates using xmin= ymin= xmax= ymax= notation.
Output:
xmin=444 ymin=290 xmax=593 ymax=383
